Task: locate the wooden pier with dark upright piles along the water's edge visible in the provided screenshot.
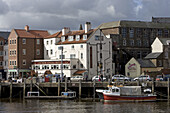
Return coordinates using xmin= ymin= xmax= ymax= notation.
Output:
xmin=0 ymin=79 xmax=170 ymax=100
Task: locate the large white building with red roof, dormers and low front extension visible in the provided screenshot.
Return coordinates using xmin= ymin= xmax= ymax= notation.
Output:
xmin=32 ymin=22 xmax=113 ymax=78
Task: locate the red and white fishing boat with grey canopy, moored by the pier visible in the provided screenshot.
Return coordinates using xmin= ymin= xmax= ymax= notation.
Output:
xmin=97 ymin=86 xmax=156 ymax=102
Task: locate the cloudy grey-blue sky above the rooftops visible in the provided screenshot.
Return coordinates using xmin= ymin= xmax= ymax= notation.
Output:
xmin=0 ymin=0 xmax=170 ymax=33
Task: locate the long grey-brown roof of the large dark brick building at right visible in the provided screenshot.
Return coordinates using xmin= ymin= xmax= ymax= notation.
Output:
xmin=100 ymin=20 xmax=170 ymax=29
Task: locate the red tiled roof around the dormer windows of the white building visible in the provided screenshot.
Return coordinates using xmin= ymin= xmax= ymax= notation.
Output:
xmin=57 ymin=29 xmax=97 ymax=45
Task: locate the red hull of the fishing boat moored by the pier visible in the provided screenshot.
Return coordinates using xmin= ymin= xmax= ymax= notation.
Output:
xmin=103 ymin=94 xmax=156 ymax=102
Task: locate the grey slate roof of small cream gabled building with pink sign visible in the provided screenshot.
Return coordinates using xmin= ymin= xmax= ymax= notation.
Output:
xmin=137 ymin=59 xmax=156 ymax=68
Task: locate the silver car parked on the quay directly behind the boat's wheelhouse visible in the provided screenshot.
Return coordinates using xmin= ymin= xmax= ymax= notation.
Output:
xmin=112 ymin=74 xmax=131 ymax=81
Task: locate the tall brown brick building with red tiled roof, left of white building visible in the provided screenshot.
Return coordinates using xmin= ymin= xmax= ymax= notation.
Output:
xmin=8 ymin=25 xmax=49 ymax=77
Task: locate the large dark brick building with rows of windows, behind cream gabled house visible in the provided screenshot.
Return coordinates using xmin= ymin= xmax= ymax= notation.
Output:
xmin=100 ymin=20 xmax=170 ymax=74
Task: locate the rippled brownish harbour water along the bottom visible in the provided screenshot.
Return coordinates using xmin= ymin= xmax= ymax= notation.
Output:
xmin=0 ymin=99 xmax=170 ymax=113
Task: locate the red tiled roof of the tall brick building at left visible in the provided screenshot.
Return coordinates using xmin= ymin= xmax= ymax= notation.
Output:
xmin=15 ymin=29 xmax=49 ymax=38
